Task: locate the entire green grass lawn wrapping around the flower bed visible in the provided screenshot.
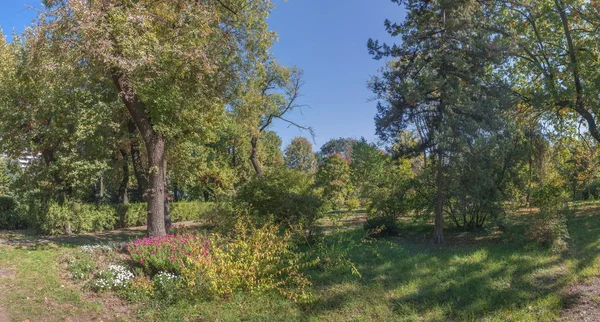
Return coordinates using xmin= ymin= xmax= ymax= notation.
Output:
xmin=0 ymin=203 xmax=600 ymax=321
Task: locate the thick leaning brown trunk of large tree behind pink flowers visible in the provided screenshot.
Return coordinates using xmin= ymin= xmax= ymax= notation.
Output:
xmin=112 ymin=71 xmax=167 ymax=237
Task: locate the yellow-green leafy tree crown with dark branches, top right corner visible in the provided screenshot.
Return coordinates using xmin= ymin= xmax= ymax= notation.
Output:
xmin=494 ymin=0 xmax=600 ymax=141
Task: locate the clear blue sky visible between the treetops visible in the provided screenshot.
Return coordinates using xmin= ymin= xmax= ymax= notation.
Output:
xmin=0 ymin=0 xmax=404 ymax=150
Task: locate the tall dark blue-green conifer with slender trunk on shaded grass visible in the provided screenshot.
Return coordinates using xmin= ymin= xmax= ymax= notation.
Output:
xmin=368 ymin=0 xmax=510 ymax=243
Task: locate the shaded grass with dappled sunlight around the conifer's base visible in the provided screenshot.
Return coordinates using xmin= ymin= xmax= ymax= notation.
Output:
xmin=302 ymin=210 xmax=600 ymax=321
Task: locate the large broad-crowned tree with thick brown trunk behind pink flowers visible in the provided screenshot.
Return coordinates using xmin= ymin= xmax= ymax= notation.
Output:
xmin=22 ymin=0 xmax=274 ymax=236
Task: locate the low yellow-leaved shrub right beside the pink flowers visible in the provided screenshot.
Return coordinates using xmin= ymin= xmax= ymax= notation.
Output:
xmin=183 ymin=221 xmax=310 ymax=301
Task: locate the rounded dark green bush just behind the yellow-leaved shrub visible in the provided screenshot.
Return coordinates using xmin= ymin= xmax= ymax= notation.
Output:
xmin=237 ymin=169 xmax=323 ymax=228
